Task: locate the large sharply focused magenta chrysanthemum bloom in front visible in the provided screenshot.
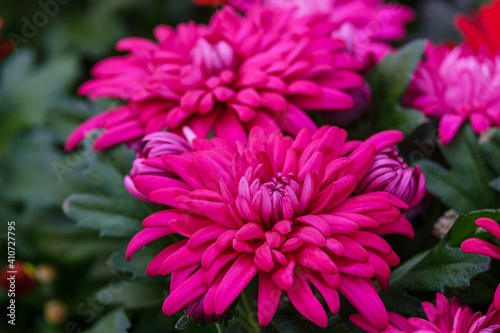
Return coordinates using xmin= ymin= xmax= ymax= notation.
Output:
xmin=126 ymin=126 xmax=413 ymax=329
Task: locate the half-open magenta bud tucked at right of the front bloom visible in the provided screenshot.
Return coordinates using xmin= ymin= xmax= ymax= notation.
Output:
xmin=358 ymin=147 xmax=426 ymax=208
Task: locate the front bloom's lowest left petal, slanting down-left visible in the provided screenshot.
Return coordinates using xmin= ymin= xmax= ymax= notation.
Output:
xmin=163 ymin=269 xmax=208 ymax=316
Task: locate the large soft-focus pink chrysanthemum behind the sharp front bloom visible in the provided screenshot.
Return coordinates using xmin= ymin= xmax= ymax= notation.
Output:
xmin=66 ymin=6 xmax=364 ymax=149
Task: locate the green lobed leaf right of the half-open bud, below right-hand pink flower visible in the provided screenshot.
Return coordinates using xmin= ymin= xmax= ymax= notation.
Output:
xmin=418 ymin=125 xmax=499 ymax=212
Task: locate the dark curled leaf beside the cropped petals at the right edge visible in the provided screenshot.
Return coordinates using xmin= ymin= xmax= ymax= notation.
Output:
xmin=449 ymin=209 xmax=500 ymax=246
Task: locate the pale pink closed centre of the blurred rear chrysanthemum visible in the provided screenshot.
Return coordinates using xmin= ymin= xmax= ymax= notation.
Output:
xmin=190 ymin=38 xmax=235 ymax=75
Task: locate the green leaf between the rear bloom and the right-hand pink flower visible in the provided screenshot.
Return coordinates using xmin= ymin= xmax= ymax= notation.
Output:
xmin=368 ymin=40 xmax=426 ymax=134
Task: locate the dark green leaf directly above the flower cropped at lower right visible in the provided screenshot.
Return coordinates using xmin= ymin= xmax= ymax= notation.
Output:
xmin=381 ymin=233 xmax=491 ymax=315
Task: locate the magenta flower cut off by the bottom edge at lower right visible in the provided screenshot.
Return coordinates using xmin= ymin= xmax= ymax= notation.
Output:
xmin=350 ymin=293 xmax=500 ymax=333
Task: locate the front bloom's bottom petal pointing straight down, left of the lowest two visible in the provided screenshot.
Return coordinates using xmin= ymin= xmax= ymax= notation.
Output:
xmin=257 ymin=272 xmax=281 ymax=326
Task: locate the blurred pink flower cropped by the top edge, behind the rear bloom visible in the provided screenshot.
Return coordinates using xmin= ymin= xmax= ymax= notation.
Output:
xmin=230 ymin=0 xmax=415 ymax=68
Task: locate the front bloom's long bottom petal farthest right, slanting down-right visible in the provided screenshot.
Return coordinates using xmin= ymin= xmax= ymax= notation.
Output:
xmin=339 ymin=275 xmax=389 ymax=330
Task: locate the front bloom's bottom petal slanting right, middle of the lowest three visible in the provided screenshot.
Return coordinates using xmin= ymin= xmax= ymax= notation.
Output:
xmin=286 ymin=274 xmax=328 ymax=327
